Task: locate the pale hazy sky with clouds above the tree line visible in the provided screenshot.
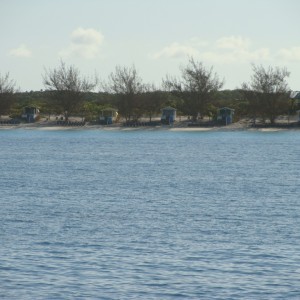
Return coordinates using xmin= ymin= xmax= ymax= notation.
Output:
xmin=0 ymin=0 xmax=300 ymax=91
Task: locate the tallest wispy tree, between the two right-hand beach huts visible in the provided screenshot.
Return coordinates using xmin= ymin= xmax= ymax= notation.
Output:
xmin=163 ymin=57 xmax=224 ymax=120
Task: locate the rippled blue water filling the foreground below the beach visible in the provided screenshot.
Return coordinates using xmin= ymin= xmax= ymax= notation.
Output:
xmin=0 ymin=129 xmax=300 ymax=299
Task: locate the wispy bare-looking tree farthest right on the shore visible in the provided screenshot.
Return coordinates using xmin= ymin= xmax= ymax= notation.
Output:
xmin=242 ymin=65 xmax=290 ymax=124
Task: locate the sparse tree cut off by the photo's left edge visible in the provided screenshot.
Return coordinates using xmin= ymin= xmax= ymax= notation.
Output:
xmin=0 ymin=73 xmax=17 ymax=116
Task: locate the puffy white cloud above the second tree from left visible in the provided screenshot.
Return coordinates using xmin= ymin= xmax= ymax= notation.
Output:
xmin=59 ymin=27 xmax=104 ymax=59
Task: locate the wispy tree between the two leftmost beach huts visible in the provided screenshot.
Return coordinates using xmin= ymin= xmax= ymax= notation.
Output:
xmin=43 ymin=61 xmax=97 ymax=121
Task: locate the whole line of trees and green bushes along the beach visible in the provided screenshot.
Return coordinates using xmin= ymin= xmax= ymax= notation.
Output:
xmin=0 ymin=57 xmax=297 ymax=124
